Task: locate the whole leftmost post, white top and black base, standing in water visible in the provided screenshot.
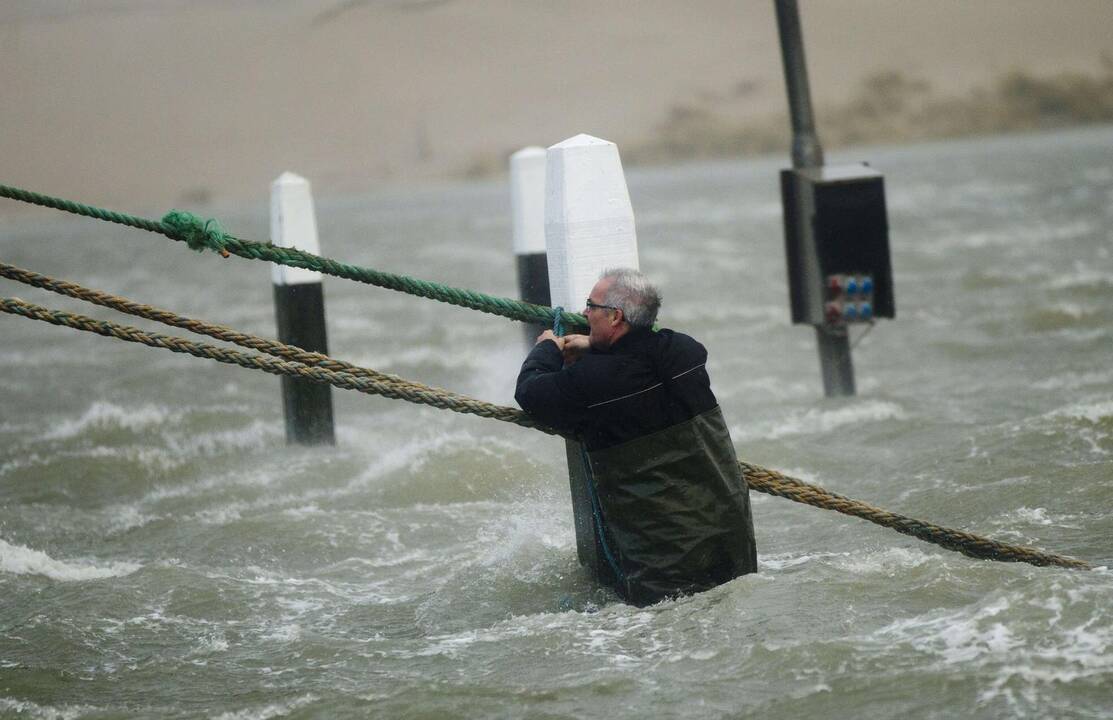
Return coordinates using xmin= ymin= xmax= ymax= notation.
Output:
xmin=270 ymin=172 xmax=336 ymax=445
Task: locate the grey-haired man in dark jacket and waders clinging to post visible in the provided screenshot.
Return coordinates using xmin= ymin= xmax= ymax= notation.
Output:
xmin=514 ymin=269 xmax=757 ymax=605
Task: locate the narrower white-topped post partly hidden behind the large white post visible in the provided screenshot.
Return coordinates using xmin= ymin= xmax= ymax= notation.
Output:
xmin=510 ymin=147 xmax=549 ymax=347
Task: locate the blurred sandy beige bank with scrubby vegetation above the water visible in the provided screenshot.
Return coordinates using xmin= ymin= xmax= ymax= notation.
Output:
xmin=0 ymin=0 xmax=1113 ymax=213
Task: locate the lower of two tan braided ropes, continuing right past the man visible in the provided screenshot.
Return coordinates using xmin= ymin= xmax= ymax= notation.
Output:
xmin=0 ymin=289 xmax=1092 ymax=570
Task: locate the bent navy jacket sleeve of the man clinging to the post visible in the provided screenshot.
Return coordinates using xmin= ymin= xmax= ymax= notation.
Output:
xmin=514 ymin=341 xmax=588 ymax=433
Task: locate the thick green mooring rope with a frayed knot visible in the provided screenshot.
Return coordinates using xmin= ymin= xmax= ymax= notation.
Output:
xmin=0 ymin=185 xmax=588 ymax=327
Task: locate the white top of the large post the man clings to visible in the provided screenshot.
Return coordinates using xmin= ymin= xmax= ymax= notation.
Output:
xmin=545 ymin=135 xmax=638 ymax=312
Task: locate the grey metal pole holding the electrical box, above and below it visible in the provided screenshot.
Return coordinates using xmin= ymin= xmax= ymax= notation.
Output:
xmin=774 ymin=0 xmax=855 ymax=397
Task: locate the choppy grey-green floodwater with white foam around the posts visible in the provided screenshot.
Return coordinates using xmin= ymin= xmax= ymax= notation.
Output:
xmin=0 ymin=128 xmax=1113 ymax=719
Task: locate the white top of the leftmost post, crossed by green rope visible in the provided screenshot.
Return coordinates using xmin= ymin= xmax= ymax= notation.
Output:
xmin=270 ymin=172 xmax=321 ymax=285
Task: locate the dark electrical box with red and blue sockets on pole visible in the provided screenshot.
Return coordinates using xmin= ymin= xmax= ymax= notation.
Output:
xmin=780 ymin=165 xmax=896 ymax=325
